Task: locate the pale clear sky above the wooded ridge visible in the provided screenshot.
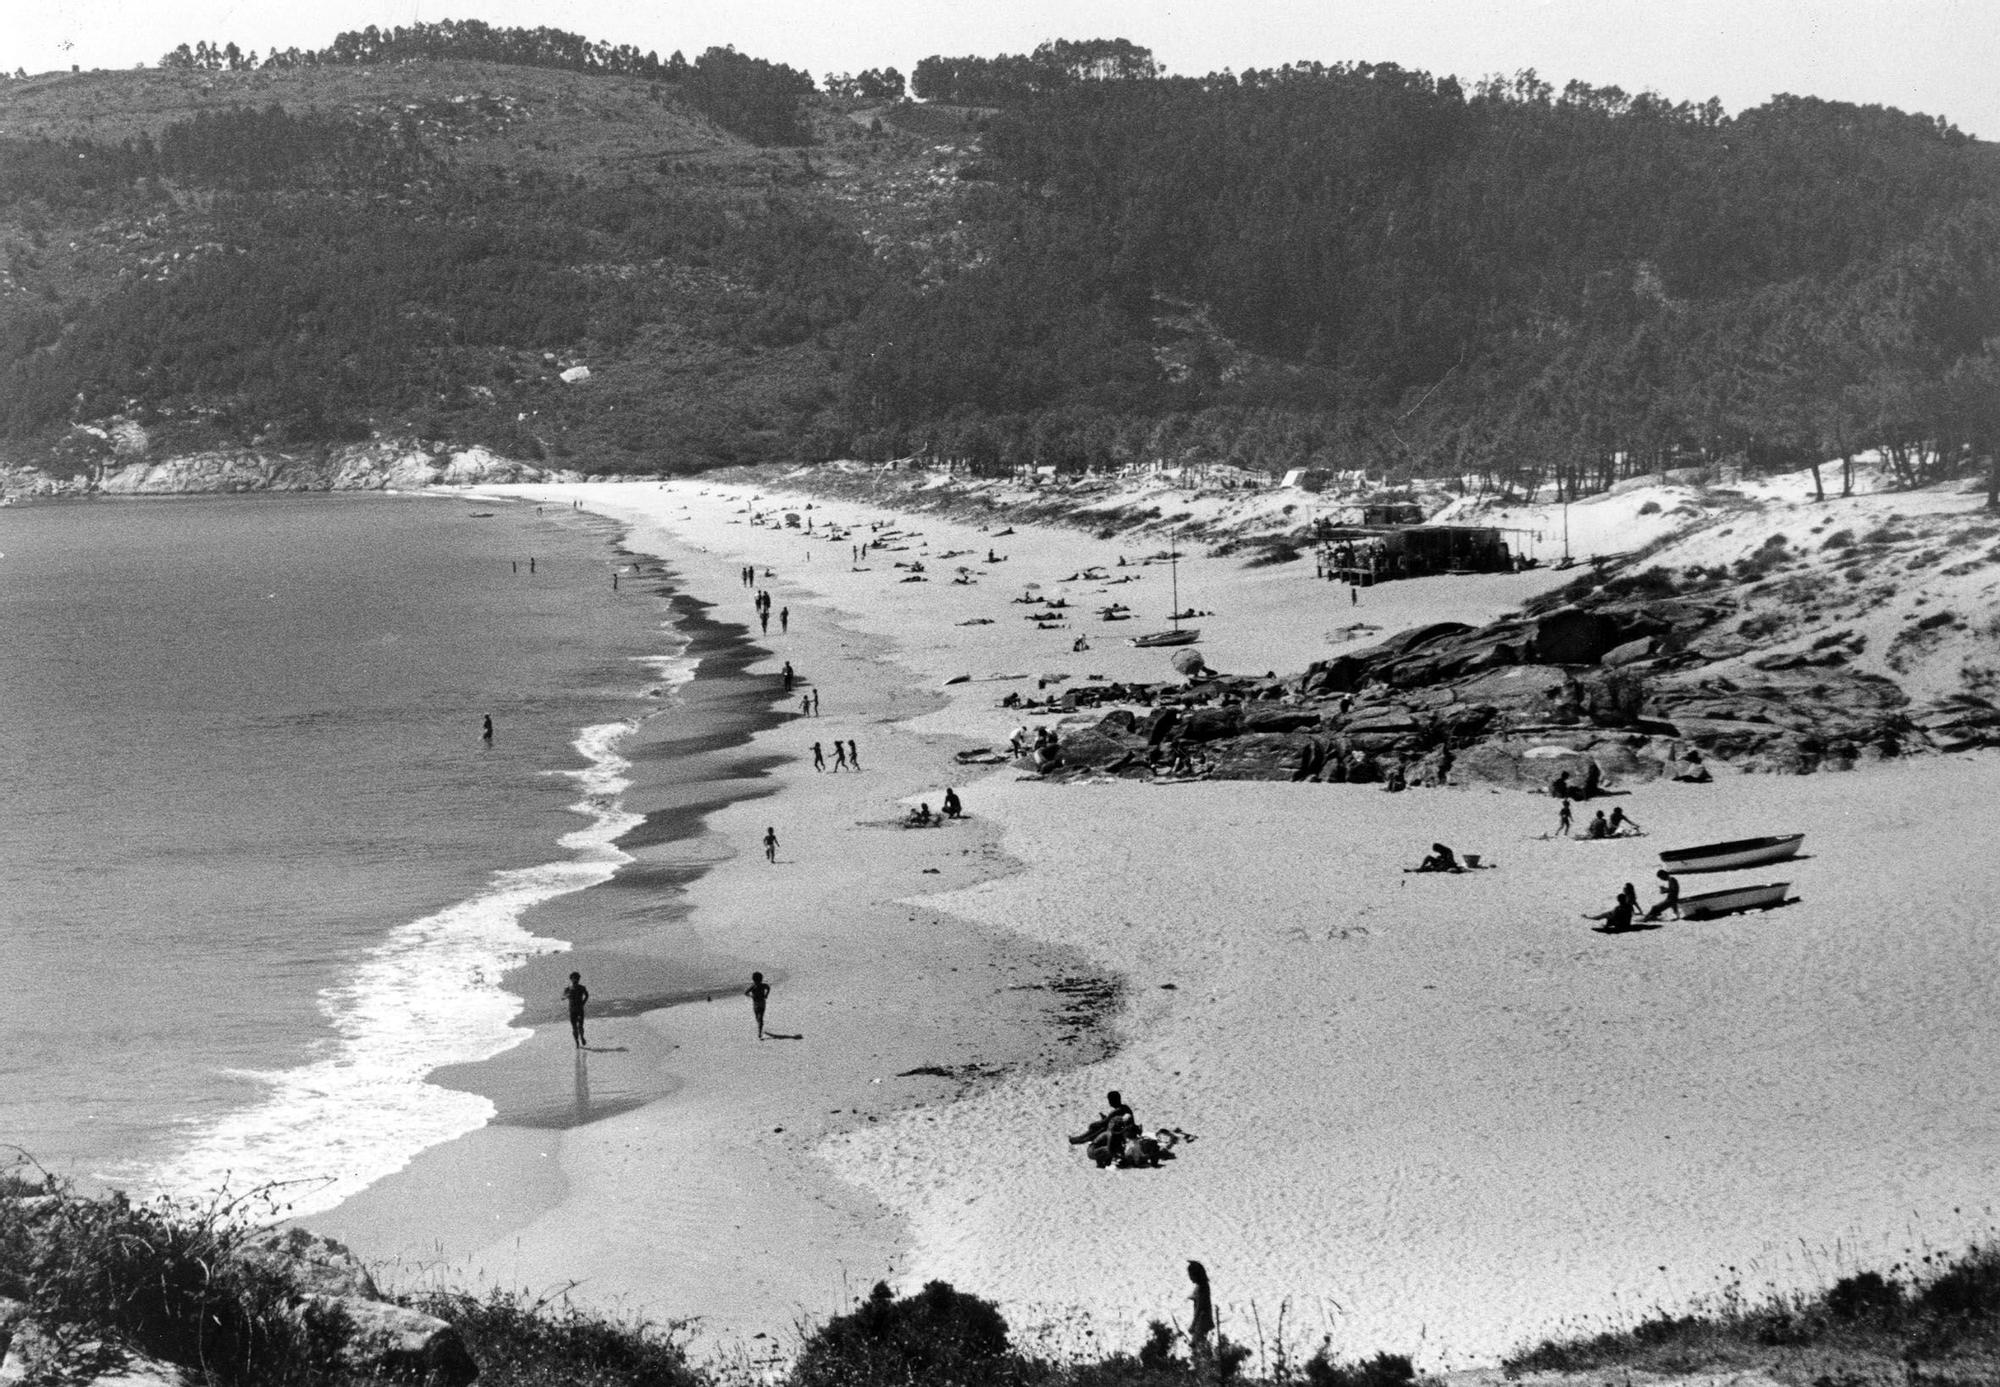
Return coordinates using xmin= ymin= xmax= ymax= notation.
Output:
xmin=0 ymin=0 xmax=2000 ymax=140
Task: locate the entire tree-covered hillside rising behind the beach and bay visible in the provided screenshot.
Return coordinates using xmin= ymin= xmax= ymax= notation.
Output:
xmin=0 ymin=22 xmax=2000 ymax=486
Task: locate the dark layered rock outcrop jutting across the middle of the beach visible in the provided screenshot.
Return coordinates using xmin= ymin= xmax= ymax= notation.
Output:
xmin=1020 ymin=579 xmax=1976 ymax=787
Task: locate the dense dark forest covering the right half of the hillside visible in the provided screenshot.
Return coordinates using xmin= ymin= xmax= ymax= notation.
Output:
xmin=848 ymin=64 xmax=2000 ymax=499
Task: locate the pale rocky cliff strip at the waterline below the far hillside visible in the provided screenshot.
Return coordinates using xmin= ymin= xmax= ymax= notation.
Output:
xmin=0 ymin=440 xmax=578 ymax=498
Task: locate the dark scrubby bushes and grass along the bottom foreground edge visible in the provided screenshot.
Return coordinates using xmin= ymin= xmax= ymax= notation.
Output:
xmin=0 ymin=1167 xmax=2000 ymax=1387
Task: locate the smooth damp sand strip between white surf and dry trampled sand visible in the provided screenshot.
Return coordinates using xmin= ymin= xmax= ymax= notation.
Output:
xmin=310 ymin=498 xmax=1102 ymax=1353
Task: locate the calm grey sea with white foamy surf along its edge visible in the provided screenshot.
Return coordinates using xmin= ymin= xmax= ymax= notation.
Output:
xmin=0 ymin=496 xmax=692 ymax=1213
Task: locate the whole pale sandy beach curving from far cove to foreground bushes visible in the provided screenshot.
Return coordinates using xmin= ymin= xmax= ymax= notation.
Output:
xmin=312 ymin=480 xmax=2000 ymax=1367
